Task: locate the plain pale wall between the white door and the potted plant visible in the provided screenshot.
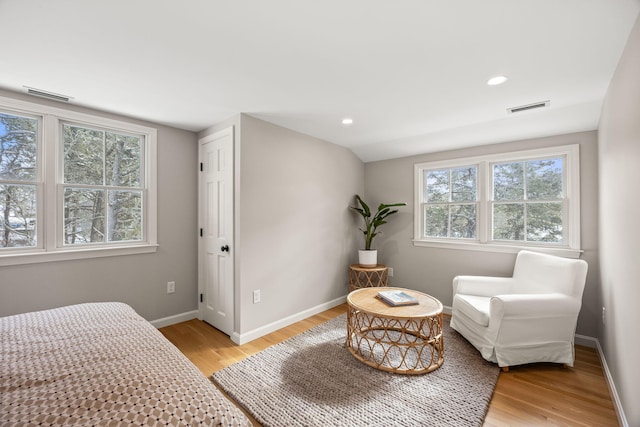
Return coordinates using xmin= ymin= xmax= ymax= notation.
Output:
xmin=199 ymin=114 xmax=364 ymax=340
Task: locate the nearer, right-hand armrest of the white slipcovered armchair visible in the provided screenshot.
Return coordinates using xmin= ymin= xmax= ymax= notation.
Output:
xmin=489 ymin=293 xmax=582 ymax=318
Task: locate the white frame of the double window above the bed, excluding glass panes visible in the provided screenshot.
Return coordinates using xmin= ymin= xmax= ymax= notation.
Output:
xmin=0 ymin=96 xmax=158 ymax=266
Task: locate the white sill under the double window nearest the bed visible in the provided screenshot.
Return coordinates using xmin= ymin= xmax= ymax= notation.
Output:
xmin=0 ymin=244 xmax=158 ymax=267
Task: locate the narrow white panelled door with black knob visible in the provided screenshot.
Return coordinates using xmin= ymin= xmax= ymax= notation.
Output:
xmin=198 ymin=127 xmax=234 ymax=335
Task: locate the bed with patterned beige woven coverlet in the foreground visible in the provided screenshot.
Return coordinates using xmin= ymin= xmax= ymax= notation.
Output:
xmin=0 ymin=303 xmax=251 ymax=426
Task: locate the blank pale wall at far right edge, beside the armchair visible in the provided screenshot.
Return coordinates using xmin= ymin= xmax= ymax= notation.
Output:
xmin=598 ymin=13 xmax=640 ymax=426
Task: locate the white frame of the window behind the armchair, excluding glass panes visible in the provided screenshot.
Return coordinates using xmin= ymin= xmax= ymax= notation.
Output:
xmin=413 ymin=144 xmax=582 ymax=258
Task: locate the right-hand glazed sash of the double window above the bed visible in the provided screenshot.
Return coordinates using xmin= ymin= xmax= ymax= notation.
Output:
xmin=62 ymin=123 xmax=144 ymax=245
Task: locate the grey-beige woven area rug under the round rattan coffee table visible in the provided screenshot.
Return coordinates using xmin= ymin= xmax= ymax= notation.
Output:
xmin=212 ymin=314 xmax=500 ymax=427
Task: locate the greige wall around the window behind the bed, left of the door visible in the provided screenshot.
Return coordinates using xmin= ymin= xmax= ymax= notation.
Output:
xmin=0 ymin=91 xmax=197 ymax=320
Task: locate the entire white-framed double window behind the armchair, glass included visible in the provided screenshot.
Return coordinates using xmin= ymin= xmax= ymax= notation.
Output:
xmin=414 ymin=145 xmax=580 ymax=256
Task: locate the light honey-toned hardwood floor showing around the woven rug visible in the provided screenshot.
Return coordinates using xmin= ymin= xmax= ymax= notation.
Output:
xmin=160 ymin=304 xmax=619 ymax=427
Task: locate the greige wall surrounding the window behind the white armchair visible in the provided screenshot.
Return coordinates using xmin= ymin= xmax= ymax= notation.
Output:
xmin=365 ymin=131 xmax=599 ymax=337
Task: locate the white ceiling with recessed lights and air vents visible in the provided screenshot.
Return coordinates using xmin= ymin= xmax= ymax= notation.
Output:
xmin=0 ymin=0 xmax=640 ymax=162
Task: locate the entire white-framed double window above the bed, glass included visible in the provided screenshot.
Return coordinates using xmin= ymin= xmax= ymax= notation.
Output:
xmin=0 ymin=98 xmax=157 ymax=265
